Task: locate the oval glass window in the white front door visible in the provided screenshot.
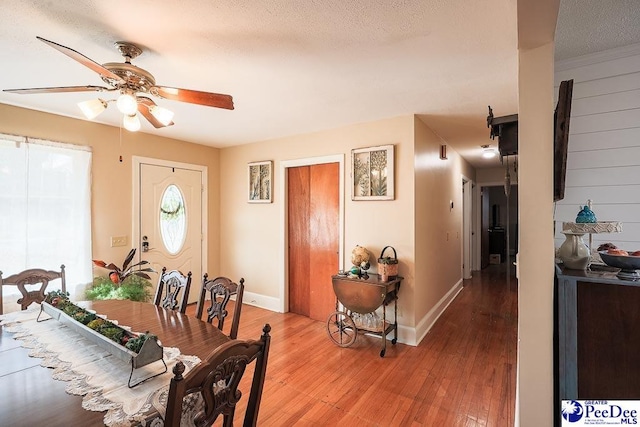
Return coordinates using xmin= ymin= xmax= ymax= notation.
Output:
xmin=160 ymin=184 xmax=187 ymax=255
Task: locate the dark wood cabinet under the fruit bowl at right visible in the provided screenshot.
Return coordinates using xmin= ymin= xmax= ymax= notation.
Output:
xmin=556 ymin=267 xmax=640 ymax=400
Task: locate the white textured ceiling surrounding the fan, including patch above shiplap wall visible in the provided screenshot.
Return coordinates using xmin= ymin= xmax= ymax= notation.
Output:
xmin=0 ymin=0 xmax=640 ymax=167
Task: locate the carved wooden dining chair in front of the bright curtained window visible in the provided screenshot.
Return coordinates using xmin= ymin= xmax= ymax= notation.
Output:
xmin=0 ymin=264 xmax=67 ymax=314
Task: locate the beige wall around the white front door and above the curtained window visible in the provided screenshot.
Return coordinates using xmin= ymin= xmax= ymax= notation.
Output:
xmin=0 ymin=104 xmax=220 ymax=280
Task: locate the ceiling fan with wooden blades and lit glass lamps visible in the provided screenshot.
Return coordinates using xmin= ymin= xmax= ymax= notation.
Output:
xmin=4 ymin=37 xmax=233 ymax=131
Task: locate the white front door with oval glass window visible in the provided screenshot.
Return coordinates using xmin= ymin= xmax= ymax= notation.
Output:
xmin=134 ymin=162 xmax=203 ymax=303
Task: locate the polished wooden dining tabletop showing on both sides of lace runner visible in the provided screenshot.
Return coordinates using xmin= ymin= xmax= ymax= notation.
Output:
xmin=0 ymin=300 xmax=229 ymax=426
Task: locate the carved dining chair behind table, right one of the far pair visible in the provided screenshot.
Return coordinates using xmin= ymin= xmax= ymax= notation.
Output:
xmin=196 ymin=273 xmax=244 ymax=339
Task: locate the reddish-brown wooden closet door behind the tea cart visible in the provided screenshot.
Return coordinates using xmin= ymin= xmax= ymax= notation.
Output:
xmin=288 ymin=163 xmax=340 ymax=321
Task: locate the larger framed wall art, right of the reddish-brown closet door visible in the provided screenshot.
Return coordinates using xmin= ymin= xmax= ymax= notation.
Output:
xmin=351 ymin=145 xmax=394 ymax=200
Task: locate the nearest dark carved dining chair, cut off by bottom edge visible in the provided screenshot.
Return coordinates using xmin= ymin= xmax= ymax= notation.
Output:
xmin=164 ymin=323 xmax=271 ymax=427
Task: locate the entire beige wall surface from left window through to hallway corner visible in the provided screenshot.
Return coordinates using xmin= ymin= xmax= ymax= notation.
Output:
xmin=0 ymin=104 xmax=473 ymax=343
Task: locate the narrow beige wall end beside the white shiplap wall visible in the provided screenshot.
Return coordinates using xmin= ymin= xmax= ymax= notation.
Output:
xmin=516 ymin=0 xmax=559 ymax=427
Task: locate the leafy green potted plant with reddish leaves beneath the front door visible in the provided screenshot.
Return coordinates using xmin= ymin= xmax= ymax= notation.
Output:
xmin=86 ymin=248 xmax=155 ymax=302
